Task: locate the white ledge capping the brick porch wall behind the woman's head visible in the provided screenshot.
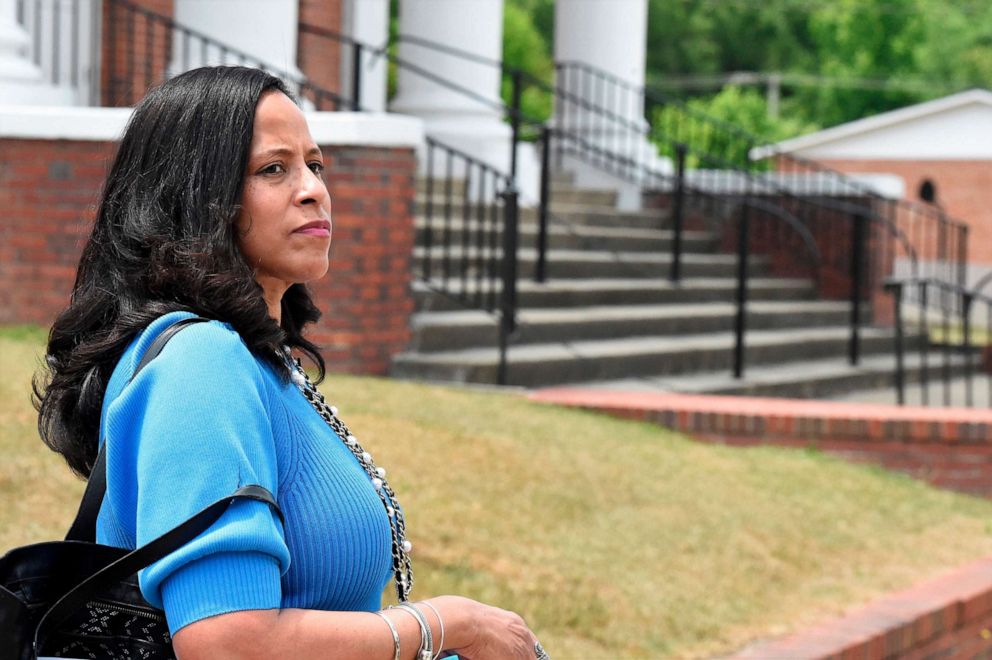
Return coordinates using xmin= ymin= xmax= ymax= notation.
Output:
xmin=0 ymin=105 xmax=424 ymax=148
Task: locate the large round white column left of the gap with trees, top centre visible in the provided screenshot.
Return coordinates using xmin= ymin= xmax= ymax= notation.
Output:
xmin=390 ymin=0 xmax=536 ymax=198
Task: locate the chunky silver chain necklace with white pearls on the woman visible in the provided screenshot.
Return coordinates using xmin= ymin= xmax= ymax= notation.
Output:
xmin=284 ymin=347 xmax=413 ymax=603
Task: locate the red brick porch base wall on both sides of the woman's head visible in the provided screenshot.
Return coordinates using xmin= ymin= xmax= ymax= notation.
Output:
xmin=0 ymin=139 xmax=416 ymax=374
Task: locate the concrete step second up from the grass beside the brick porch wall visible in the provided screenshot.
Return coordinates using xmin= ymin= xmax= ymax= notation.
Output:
xmin=410 ymin=301 xmax=849 ymax=352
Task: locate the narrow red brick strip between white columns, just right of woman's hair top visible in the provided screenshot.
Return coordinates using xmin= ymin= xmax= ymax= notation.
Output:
xmin=297 ymin=0 xmax=348 ymax=110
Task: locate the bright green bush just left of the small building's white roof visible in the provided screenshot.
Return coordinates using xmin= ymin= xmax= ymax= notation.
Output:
xmin=651 ymin=85 xmax=817 ymax=168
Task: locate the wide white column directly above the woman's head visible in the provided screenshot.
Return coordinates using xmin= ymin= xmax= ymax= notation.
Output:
xmin=171 ymin=0 xmax=303 ymax=77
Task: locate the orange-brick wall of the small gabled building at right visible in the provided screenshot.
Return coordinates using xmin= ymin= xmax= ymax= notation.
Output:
xmin=823 ymin=160 xmax=992 ymax=263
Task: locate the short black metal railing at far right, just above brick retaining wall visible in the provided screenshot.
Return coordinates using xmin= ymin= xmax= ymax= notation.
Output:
xmin=885 ymin=277 xmax=992 ymax=408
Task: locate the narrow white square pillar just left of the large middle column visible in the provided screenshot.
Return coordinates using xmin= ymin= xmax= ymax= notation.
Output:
xmin=341 ymin=0 xmax=389 ymax=112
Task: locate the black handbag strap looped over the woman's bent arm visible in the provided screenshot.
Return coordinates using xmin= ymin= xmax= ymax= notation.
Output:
xmin=34 ymin=486 xmax=286 ymax=655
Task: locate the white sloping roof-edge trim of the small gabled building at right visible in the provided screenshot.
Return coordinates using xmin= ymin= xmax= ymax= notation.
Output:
xmin=750 ymin=89 xmax=992 ymax=159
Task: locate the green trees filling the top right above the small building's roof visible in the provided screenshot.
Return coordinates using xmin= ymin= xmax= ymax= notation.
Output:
xmin=647 ymin=0 xmax=992 ymax=126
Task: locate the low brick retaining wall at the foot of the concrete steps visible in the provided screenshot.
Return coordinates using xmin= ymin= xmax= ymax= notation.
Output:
xmin=531 ymin=388 xmax=992 ymax=497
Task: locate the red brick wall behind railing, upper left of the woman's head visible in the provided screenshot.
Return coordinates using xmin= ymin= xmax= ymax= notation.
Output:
xmin=100 ymin=0 xmax=175 ymax=107
